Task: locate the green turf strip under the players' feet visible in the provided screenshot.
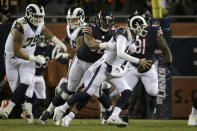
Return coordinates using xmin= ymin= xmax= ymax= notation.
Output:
xmin=0 ymin=119 xmax=197 ymax=131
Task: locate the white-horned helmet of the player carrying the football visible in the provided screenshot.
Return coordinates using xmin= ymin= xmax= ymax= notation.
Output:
xmin=128 ymin=16 xmax=148 ymax=37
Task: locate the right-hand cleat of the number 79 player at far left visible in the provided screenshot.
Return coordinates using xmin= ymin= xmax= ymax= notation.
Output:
xmin=22 ymin=103 xmax=34 ymax=124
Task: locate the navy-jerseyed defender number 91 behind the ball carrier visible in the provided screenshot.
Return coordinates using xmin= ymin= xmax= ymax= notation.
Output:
xmin=112 ymin=9 xmax=172 ymax=122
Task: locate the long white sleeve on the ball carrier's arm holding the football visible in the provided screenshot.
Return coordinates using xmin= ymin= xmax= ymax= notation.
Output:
xmin=116 ymin=35 xmax=139 ymax=64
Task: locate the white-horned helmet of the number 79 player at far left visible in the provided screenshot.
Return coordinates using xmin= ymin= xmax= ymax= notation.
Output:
xmin=25 ymin=4 xmax=45 ymax=26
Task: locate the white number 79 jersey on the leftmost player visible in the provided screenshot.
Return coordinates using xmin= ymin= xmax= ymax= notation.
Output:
xmin=5 ymin=17 xmax=44 ymax=55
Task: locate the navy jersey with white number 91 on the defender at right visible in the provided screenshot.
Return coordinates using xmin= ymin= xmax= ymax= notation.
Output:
xmin=133 ymin=26 xmax=159 ymax=61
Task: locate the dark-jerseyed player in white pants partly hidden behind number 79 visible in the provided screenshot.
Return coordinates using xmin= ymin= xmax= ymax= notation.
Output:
xmin=23 ymin=35 xmax=66 ymax=118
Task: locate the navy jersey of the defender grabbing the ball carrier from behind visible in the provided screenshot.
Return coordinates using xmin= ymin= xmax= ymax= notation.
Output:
xmin=77 ymin=24 xmax=115 ymax=63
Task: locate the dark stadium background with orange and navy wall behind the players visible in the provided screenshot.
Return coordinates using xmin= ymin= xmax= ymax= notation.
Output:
xmin=0 ymin=0 xmax=197 ymax=119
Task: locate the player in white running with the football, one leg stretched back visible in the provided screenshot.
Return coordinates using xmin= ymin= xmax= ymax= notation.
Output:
xmin=55 ymin=16 xmax=150 ymax=126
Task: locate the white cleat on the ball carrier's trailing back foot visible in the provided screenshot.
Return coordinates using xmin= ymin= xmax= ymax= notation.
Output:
xmin=53 ymin=107 xmax=64 ymax=126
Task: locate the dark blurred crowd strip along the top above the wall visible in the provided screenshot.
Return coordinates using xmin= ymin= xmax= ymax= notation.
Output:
xmin=0 ymin=0 xmax=197 ymax=16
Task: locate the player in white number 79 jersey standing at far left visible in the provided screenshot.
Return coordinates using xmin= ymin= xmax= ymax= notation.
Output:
xmin=0 ymin=4 xmax=67 ymax=124
